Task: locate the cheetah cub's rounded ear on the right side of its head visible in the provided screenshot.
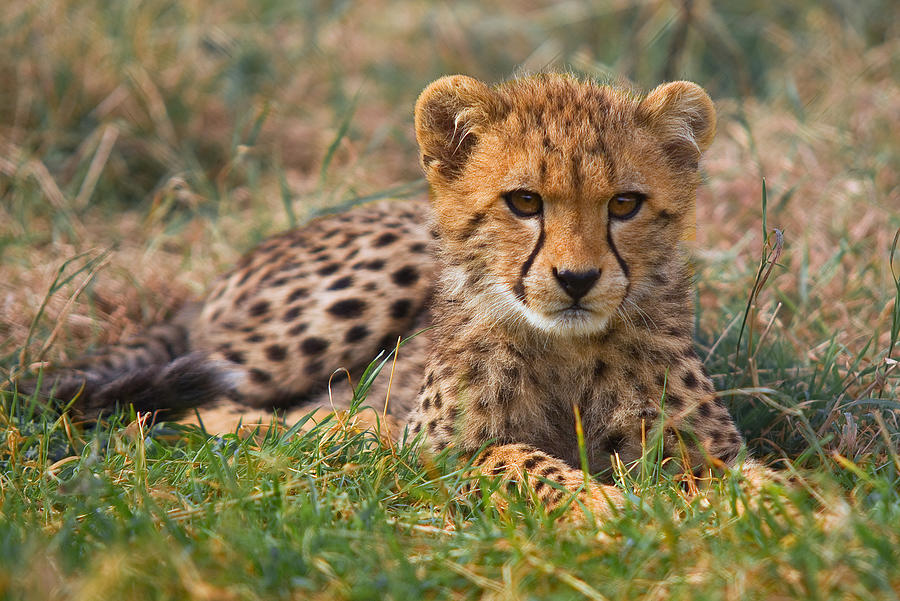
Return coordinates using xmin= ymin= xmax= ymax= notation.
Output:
xmin=637 ymin=81 xmax=716 ymax=171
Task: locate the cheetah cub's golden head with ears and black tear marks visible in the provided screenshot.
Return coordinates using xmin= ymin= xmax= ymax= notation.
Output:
xmin=416 ymin=75 xmax=715 ymax=336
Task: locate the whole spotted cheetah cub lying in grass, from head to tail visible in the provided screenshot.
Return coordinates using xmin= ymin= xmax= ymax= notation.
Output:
xmin=26 ymin=75 xmax=742 ymax=516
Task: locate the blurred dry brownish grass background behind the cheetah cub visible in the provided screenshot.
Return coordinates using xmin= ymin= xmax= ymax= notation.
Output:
xmin=0 ymin=0 xmax=900 ymax=457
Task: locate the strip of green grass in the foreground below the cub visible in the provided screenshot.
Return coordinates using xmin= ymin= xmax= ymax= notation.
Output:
xmin=0 ymin=384 xmax=900 ymax=599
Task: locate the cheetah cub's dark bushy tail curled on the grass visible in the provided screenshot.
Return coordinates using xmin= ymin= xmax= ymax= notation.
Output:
xmin=18 ymin=322 xmax=240 ymax=421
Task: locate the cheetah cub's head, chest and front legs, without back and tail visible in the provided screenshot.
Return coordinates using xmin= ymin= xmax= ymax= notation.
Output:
xmin=409 ymin=76 xmax=741 ymax=515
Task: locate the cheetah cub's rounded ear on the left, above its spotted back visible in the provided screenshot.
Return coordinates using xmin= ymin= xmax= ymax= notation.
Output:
xmin=416 ymin=75 xmax=503 ymax=181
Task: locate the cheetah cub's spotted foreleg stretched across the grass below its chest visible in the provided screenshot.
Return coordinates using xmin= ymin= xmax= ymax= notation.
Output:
xmin=473 ymin=444 xmax=625 ymax=520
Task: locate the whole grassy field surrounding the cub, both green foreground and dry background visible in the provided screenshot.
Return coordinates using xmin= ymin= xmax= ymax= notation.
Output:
xmin=0 ymin=0 xmax=900 ymax=600
